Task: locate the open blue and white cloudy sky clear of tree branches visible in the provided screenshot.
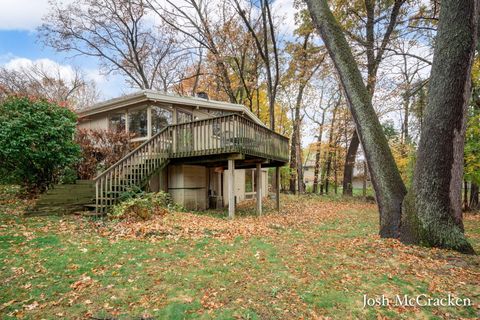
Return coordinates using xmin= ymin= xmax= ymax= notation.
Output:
xmin=0 ymin=0 xmax=294 ymax=99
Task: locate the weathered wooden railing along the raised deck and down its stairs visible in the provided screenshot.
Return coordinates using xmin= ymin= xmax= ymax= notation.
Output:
xmin=94 ymin=114 xmax=288 ymax=213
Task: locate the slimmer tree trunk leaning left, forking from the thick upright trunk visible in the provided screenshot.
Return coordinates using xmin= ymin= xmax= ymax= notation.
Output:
xmin=306 ymin=0 xmax=406 ymax=238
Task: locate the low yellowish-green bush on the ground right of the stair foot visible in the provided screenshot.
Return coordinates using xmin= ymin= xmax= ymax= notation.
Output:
xmin=109 ymin=191 xmax=180 ymax=220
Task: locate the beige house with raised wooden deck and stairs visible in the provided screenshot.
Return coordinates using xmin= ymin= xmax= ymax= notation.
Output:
xmin=73 ymin=90 xmax=288 ymax=216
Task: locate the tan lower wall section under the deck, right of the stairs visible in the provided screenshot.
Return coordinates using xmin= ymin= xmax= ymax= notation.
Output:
xmin=168 ymin=165 xmax=207 ymax=210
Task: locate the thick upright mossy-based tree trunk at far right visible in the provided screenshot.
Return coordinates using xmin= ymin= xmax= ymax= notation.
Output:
xmin=402 ymin=0 xmax=479 ymax=253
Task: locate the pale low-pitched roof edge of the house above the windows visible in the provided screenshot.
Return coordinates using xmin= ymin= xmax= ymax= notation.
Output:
xmin=78 ymin=90 xmax=265 ymax=126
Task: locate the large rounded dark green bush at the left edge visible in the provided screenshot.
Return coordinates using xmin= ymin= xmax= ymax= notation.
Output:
xmin=0 ymin=97 xmax=80 ymax=195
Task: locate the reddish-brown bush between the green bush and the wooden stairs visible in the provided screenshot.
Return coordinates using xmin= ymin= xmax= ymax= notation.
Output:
xmin=75 ymin=129 xmax=134 ymax=180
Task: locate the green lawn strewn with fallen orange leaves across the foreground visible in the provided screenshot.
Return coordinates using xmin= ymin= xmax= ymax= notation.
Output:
xmin=0 ymin=187 xmax=480 ymax=319
